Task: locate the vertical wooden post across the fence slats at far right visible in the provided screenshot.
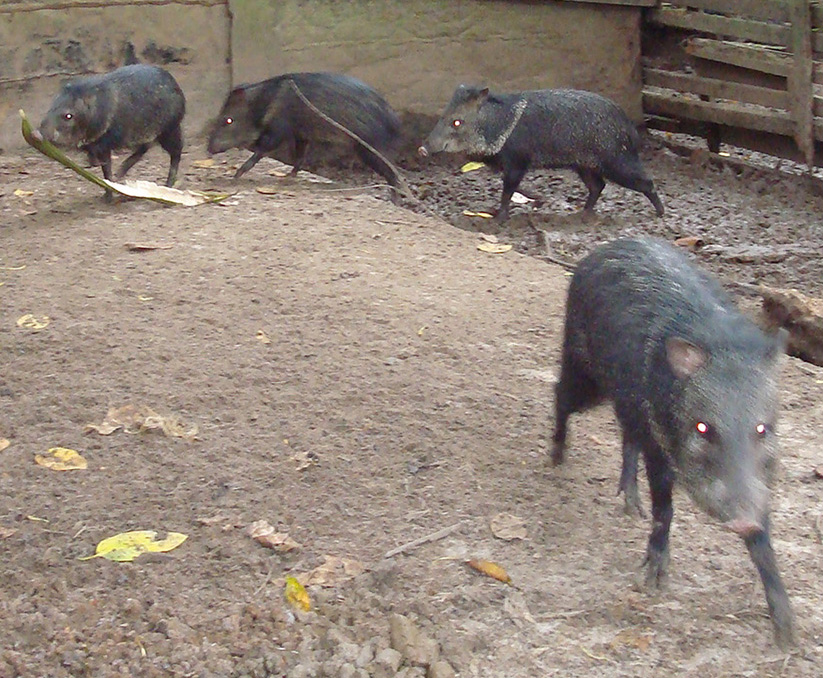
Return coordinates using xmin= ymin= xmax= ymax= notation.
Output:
xmin=787 ymin=0 xmax=814 ymax=171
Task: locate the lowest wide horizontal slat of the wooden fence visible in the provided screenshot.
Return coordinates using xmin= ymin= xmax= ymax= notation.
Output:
xmin=643 ymin=89 xmax=795 ymax=137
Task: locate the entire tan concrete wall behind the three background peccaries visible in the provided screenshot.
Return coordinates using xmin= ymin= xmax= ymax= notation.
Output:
xmin=0 ymin=0 xmax=642 ymax=149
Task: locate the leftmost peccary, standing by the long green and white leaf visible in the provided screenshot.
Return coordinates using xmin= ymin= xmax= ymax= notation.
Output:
xmin=40 ymin=64 xmax=186 ymax=199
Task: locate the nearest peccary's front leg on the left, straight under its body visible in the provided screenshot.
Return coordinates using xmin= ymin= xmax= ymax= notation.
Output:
xmin=643 ymin=443 xmax=674 ymax=589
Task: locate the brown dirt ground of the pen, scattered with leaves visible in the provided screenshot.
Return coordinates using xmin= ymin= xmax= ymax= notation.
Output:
xmin=0 ymin=134 xmax=823 ymax=678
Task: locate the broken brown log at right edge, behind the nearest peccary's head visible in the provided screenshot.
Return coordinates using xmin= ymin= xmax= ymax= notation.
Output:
xmin=758 ymin=285 xmax=823 ymax=366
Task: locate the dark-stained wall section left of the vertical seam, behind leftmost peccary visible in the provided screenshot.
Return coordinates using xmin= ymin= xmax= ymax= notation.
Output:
xmin=0 ymin=0 xmax=231 ymax=153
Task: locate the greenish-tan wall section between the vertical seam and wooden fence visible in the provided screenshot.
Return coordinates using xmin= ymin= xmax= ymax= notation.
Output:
xmin=229 ymin=0 xmax=642 ymax=121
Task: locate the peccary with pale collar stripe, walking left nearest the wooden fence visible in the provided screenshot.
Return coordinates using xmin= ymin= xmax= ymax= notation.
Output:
xmin=418 ymin=85 xmax=663 ymax=221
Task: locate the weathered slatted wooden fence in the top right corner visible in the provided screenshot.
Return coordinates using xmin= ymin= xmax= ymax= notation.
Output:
xmin=642 ymin=0 xmax=823 ymax=167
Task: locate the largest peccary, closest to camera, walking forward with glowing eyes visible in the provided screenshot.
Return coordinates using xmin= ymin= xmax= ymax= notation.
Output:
xmin=552 ymin=239 xmax=793 ymax=646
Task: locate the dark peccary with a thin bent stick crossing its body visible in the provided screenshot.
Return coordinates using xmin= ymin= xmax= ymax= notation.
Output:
xmin=209 ymin=73 xmax=400 ymax=200
